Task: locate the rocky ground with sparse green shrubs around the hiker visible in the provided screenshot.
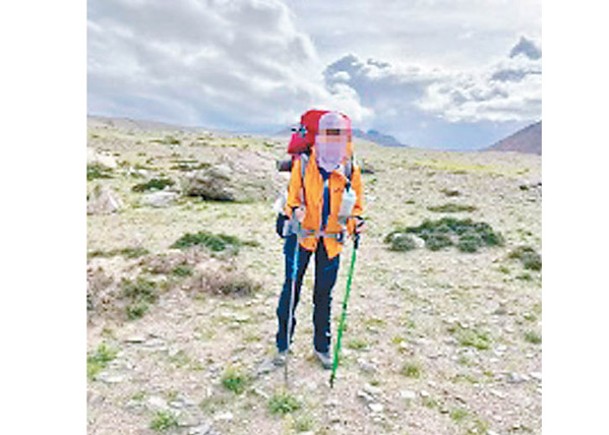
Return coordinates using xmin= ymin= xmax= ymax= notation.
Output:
xmin=82 ymin=116 xmax=542 ymax=435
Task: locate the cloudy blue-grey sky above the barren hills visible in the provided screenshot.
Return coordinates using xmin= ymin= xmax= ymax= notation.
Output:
xmin=87 ymin=0 xmax=542 ymax=149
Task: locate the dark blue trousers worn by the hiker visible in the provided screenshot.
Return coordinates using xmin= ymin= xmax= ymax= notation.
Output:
xmin=276 ymin=235 xmax=340 ymax=352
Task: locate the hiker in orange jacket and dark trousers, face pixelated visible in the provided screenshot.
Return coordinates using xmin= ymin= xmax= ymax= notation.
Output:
xmin=273 ymin=112 xmax=364 ymax=369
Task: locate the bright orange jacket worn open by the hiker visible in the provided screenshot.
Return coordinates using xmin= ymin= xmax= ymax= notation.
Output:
xmin=285 ymin=150 xmax=364 ymax=258
